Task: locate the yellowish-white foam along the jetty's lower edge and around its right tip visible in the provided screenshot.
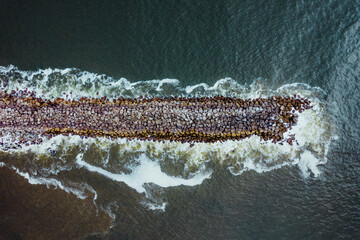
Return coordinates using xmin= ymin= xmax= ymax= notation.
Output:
xmin=0 ymin=102 xmax=330 ymax=180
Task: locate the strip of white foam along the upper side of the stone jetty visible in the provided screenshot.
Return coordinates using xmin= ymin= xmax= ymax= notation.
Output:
xmin=0 ymin=65 xmax=319 ymax=99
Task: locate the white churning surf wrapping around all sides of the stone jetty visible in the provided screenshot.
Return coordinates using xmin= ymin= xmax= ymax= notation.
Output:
xmin=0 ymin=65 xmax=336 ymax=210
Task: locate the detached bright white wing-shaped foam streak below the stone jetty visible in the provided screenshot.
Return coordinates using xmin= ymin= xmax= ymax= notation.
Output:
xmin=76 ymin=153 xmax=211 ymax=193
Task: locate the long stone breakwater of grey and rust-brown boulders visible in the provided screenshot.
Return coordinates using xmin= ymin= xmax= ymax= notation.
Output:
xmin=0 ymin=90 xmax=311 ymax=145
